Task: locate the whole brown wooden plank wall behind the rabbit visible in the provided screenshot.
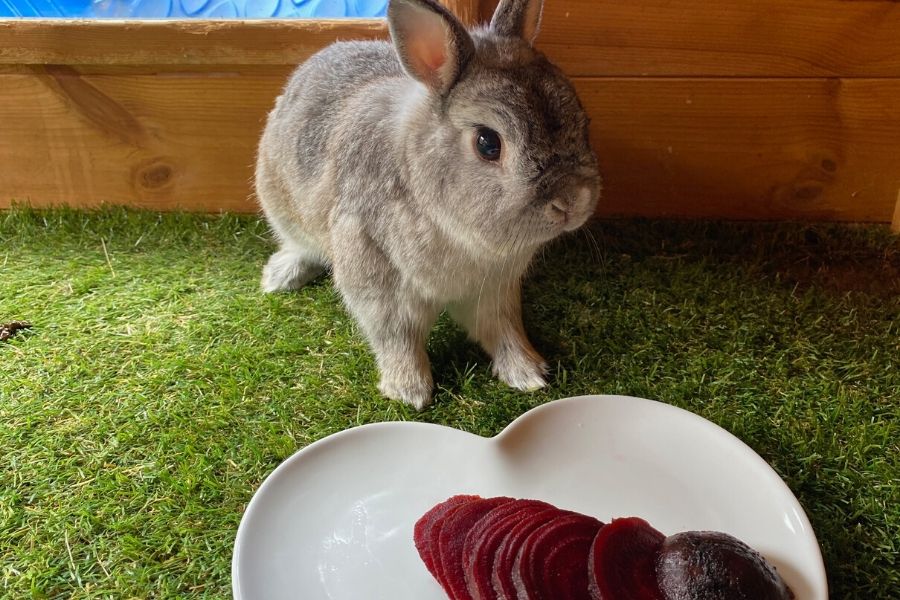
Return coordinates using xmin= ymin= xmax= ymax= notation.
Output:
xmin=0 ymin=0 xmax=900 ymax=222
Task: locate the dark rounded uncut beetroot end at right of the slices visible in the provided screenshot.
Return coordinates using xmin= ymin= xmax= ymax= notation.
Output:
xmin=656 ymin=531 xmax=794 ymax=600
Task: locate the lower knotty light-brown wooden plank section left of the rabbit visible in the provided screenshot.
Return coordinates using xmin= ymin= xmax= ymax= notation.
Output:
xmin=0 ymin=67 xmax=286 ymax=211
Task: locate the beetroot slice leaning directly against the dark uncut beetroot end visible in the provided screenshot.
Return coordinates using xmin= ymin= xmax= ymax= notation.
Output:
xmin=588 ymin=517 xmax=666 ymax=600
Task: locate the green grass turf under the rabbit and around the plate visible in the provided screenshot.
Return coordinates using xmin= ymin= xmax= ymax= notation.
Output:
xmin=0 ymin=208 xmax=900 ymax=600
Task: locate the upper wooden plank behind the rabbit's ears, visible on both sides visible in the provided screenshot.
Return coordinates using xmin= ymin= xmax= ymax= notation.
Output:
xmin=0 ymin=0 xmax=900 ymax=78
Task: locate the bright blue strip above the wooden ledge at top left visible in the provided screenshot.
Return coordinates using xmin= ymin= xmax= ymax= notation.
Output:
xmin=0 ymin=0 xmax=387 ymax=19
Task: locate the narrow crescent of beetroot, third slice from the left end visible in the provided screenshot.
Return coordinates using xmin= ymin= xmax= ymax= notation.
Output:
xmin=463 ymin=500 xmax=554 ymax=600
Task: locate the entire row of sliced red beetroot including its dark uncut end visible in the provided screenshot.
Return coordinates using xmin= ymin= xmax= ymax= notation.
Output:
xmin=414 ymin=495 xmax=794 ymax=600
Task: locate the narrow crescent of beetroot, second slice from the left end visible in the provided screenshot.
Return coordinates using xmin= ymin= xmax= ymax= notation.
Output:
xmin=432 ymin=497 xmax=513 ymax=600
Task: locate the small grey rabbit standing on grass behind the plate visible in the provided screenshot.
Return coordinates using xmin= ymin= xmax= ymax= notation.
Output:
xmin=256 ymin=0 xmax=600 ymax=409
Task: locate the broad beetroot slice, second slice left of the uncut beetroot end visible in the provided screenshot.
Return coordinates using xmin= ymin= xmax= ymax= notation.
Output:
xmin=513 ymin=514 xmax=603 ymax=600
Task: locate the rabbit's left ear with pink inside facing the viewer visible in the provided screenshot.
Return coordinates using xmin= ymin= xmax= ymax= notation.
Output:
xmin=387 ymin=0 xmax=475 ymax=96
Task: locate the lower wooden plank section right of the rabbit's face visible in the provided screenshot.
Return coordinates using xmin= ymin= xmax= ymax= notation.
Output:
xmin=576 ymin=78 xmax=900 ymax=222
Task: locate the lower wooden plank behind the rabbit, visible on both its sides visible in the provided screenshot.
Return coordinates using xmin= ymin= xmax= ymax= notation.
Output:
xmin=0 ymin=67 xmax=900 ymax=223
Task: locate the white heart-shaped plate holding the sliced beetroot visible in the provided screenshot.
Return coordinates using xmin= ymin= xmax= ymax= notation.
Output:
xmin=232 ymin=396 xmax=828 ymax=600
